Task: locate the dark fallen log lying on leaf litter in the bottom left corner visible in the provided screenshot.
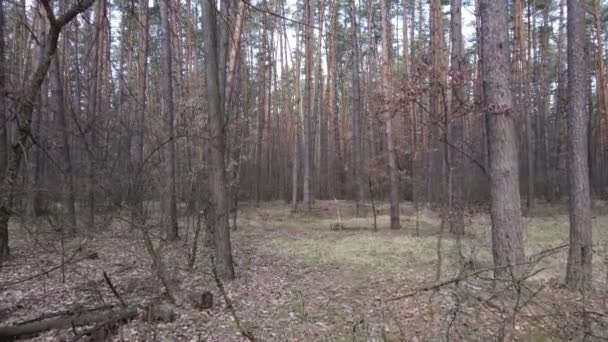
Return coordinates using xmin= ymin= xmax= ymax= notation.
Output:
xmin=0 ymin=308 xmax=137 ymax=341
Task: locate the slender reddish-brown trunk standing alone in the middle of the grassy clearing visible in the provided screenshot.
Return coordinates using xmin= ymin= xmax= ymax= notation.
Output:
xmin=380 ymin=0 xmax=401 ymax=229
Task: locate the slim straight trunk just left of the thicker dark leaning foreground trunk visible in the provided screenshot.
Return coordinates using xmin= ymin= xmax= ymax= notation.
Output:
xmin=160 ymin=0 xmax=179 ymax=241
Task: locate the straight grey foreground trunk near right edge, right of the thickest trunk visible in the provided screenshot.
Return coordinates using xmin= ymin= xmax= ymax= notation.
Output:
xmin=566 ymin=0 xmax=593 ymax=290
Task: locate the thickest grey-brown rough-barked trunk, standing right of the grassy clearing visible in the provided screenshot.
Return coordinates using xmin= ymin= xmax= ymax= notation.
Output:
xmin=480 ymin=0 xmax=524 ymax=276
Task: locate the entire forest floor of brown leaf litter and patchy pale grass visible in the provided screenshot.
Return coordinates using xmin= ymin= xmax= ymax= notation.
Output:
xmin=0 ymin=201 xmax=608 ymax=341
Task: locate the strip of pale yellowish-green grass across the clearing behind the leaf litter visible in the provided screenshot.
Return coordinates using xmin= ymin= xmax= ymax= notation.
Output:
xmin=239 ymin=201 xmax=608 ymax=279
